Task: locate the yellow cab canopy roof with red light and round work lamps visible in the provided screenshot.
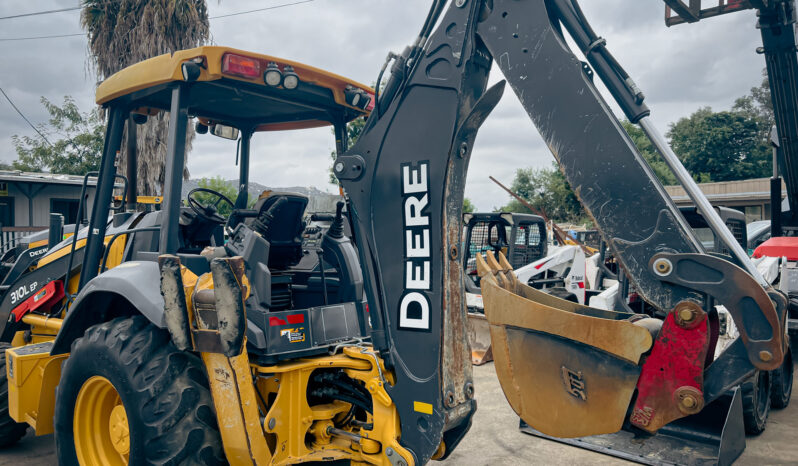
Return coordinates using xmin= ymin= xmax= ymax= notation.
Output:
xmin=96 ymin=46 xmax=374 ymax=131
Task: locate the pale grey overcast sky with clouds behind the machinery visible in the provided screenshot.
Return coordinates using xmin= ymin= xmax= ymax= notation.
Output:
xmin=0 ymin=0 xmax=764 ymax=210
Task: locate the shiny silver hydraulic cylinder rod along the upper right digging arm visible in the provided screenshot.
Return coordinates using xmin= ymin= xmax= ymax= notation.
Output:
xmin=638 ymin=117 xmax=770 ymax=287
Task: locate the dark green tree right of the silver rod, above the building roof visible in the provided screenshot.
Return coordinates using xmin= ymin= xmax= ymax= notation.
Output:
xmin=668 ymin=107 xmax=771 ymax=182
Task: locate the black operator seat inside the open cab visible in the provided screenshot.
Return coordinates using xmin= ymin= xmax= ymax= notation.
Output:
xmin=248 ymin=191 xmax=308 ymax=270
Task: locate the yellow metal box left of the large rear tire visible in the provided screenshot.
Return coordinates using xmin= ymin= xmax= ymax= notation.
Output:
xmin=6 ymin=346 xmax=68 ymax=435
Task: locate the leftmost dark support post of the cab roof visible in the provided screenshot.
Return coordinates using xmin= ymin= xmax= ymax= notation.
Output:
xmin=76 ymin=107 xmax=128 ymax=289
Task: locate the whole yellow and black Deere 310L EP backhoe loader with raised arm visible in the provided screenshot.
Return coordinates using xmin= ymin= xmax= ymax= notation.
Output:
xmin=0 ymin=0 xmax=786 ymax=466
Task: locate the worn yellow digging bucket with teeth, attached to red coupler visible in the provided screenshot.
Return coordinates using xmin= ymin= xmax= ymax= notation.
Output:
xmin=477 ymin=252 xmax=653 ymax=438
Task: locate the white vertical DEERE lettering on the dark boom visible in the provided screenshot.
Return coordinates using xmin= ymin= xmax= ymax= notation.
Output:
xmin=399 ymin=162 xmax=432 ymax=331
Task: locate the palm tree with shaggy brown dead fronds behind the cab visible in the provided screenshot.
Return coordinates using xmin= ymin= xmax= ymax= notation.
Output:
xmin=80 ymin=0 xmax=210 ymax=195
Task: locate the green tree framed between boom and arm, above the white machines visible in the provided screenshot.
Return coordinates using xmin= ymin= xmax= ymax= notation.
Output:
xmin=501 ymin=163 xmax=589 ymax=223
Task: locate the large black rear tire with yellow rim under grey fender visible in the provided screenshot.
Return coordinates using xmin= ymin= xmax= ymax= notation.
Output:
xmin=55 ymin=316 xmax=226 ymax=465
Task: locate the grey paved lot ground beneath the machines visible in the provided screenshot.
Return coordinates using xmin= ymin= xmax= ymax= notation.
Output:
xmin=0 ymin=363 xmax=798 ymax=466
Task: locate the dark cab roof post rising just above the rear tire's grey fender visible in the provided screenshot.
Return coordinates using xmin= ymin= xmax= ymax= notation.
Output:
xmin=159 ymin=83 xmax=189 ymax=254
